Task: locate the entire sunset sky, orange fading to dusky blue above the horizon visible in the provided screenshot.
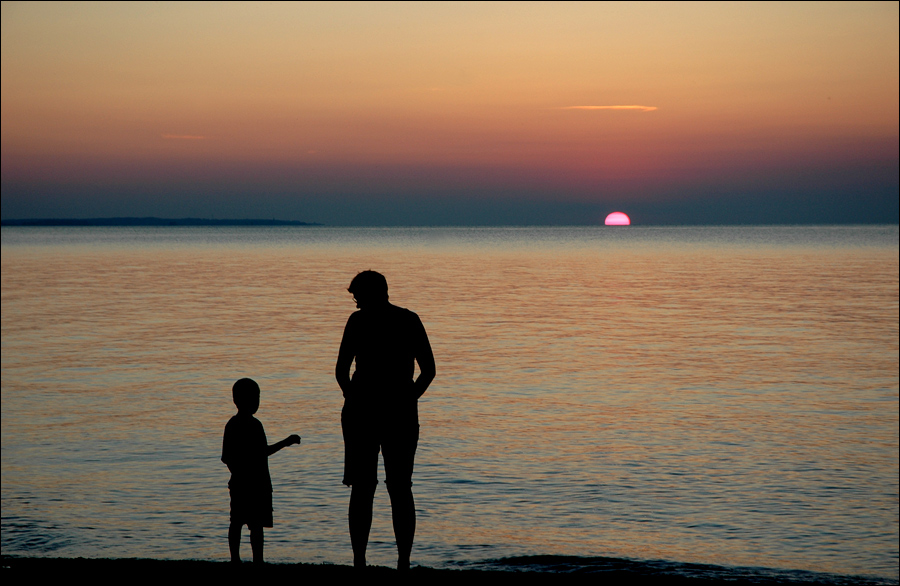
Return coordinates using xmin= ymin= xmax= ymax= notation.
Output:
xmin=0 ymin=2 xmax=900 ymax=225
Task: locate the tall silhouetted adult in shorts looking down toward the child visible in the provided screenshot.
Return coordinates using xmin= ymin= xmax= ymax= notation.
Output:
xmin=335 ymin=271 xmax=435 ymax=570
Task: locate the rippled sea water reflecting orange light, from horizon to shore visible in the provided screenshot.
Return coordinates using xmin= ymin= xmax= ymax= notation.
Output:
xmin=0 ymin=226 xmax=900 ymax=583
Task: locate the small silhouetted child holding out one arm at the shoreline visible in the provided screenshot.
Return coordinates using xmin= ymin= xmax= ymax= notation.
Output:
xmin=222 ymin=378 xmax=300 ymax=564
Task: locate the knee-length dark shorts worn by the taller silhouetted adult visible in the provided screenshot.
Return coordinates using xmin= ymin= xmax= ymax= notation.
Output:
xmin=341 ymin=407 xmax=419 ymax=488
